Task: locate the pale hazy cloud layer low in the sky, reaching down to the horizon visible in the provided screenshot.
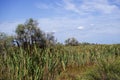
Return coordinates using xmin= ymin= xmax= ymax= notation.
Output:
xmin=0 ymin=17 xmax=120 ymax=43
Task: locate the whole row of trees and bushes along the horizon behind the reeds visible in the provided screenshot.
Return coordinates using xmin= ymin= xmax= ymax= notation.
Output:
xmin=0 ymin=18 xmax=95 ymax=48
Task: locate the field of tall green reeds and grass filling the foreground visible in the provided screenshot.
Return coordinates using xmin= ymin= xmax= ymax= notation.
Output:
xmin=0 ymin=44 xmax=120 ymax=80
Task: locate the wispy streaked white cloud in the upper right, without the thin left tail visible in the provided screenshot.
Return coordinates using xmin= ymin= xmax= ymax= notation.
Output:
xmin=63 ymin=0 xmax=120 ymax=15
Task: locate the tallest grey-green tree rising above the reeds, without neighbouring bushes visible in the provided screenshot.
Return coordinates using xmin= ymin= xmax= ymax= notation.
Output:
xmin=15 ymin=18 xmax=46 ymax=47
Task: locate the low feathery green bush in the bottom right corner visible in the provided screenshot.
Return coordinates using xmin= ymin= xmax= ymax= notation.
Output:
xmin=81 ymin=57 xmax=120 ymax=80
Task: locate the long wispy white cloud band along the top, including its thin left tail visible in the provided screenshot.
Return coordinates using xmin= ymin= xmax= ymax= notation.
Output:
xmin=35 ymin=0 xmax=120 ymax=16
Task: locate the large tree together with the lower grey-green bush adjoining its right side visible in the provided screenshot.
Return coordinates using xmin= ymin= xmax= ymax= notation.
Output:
xmin=15 ymin=18 xmax=56 ymax=48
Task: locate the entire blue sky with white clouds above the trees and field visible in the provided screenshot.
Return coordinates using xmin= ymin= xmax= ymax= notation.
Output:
xmin=0 ymin=0 xmax=120 ymax=44
